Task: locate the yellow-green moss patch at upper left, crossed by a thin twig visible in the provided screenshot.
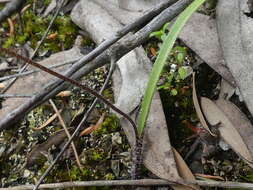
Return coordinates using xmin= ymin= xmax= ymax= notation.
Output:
xmin=3 ymin=7 xmax=78 ymax=52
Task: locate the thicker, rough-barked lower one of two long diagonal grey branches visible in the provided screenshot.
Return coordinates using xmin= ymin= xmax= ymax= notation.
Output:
xmin=0 ymin=0 xmax=192 ymax=131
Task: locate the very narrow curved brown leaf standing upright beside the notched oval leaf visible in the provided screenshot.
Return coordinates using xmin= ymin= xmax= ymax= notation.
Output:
xmin=192 ymin=72 xmax=216 ymax=136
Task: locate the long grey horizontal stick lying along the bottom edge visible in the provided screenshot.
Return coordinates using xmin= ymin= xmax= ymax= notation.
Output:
xmin=0 ymin=179 xmax=253 ymax=190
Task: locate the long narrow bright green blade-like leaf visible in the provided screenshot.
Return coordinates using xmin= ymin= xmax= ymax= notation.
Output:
xmin=138 ymin=0 xmax=205 ymax=135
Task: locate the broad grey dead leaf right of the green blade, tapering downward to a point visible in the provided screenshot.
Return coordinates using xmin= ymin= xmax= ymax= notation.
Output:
xmin=179 ymin=13 xmax=235 ymax=86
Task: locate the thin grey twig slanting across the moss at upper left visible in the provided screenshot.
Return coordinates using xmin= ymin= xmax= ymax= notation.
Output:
xmin=2 ymin=0 xmax=64 ymax=93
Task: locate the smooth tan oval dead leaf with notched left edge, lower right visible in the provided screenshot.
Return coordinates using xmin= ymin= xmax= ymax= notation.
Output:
xmin=201 ymin=97 xmax=253 ymax=162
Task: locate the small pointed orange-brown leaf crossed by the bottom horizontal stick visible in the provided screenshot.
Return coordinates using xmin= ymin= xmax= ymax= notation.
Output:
xmin=172 ymin=148 xmax=200 ymax=190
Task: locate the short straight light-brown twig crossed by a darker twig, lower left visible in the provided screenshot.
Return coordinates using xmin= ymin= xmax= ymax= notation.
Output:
xmin=49 ymin=99 xmax=82 ymax=170
